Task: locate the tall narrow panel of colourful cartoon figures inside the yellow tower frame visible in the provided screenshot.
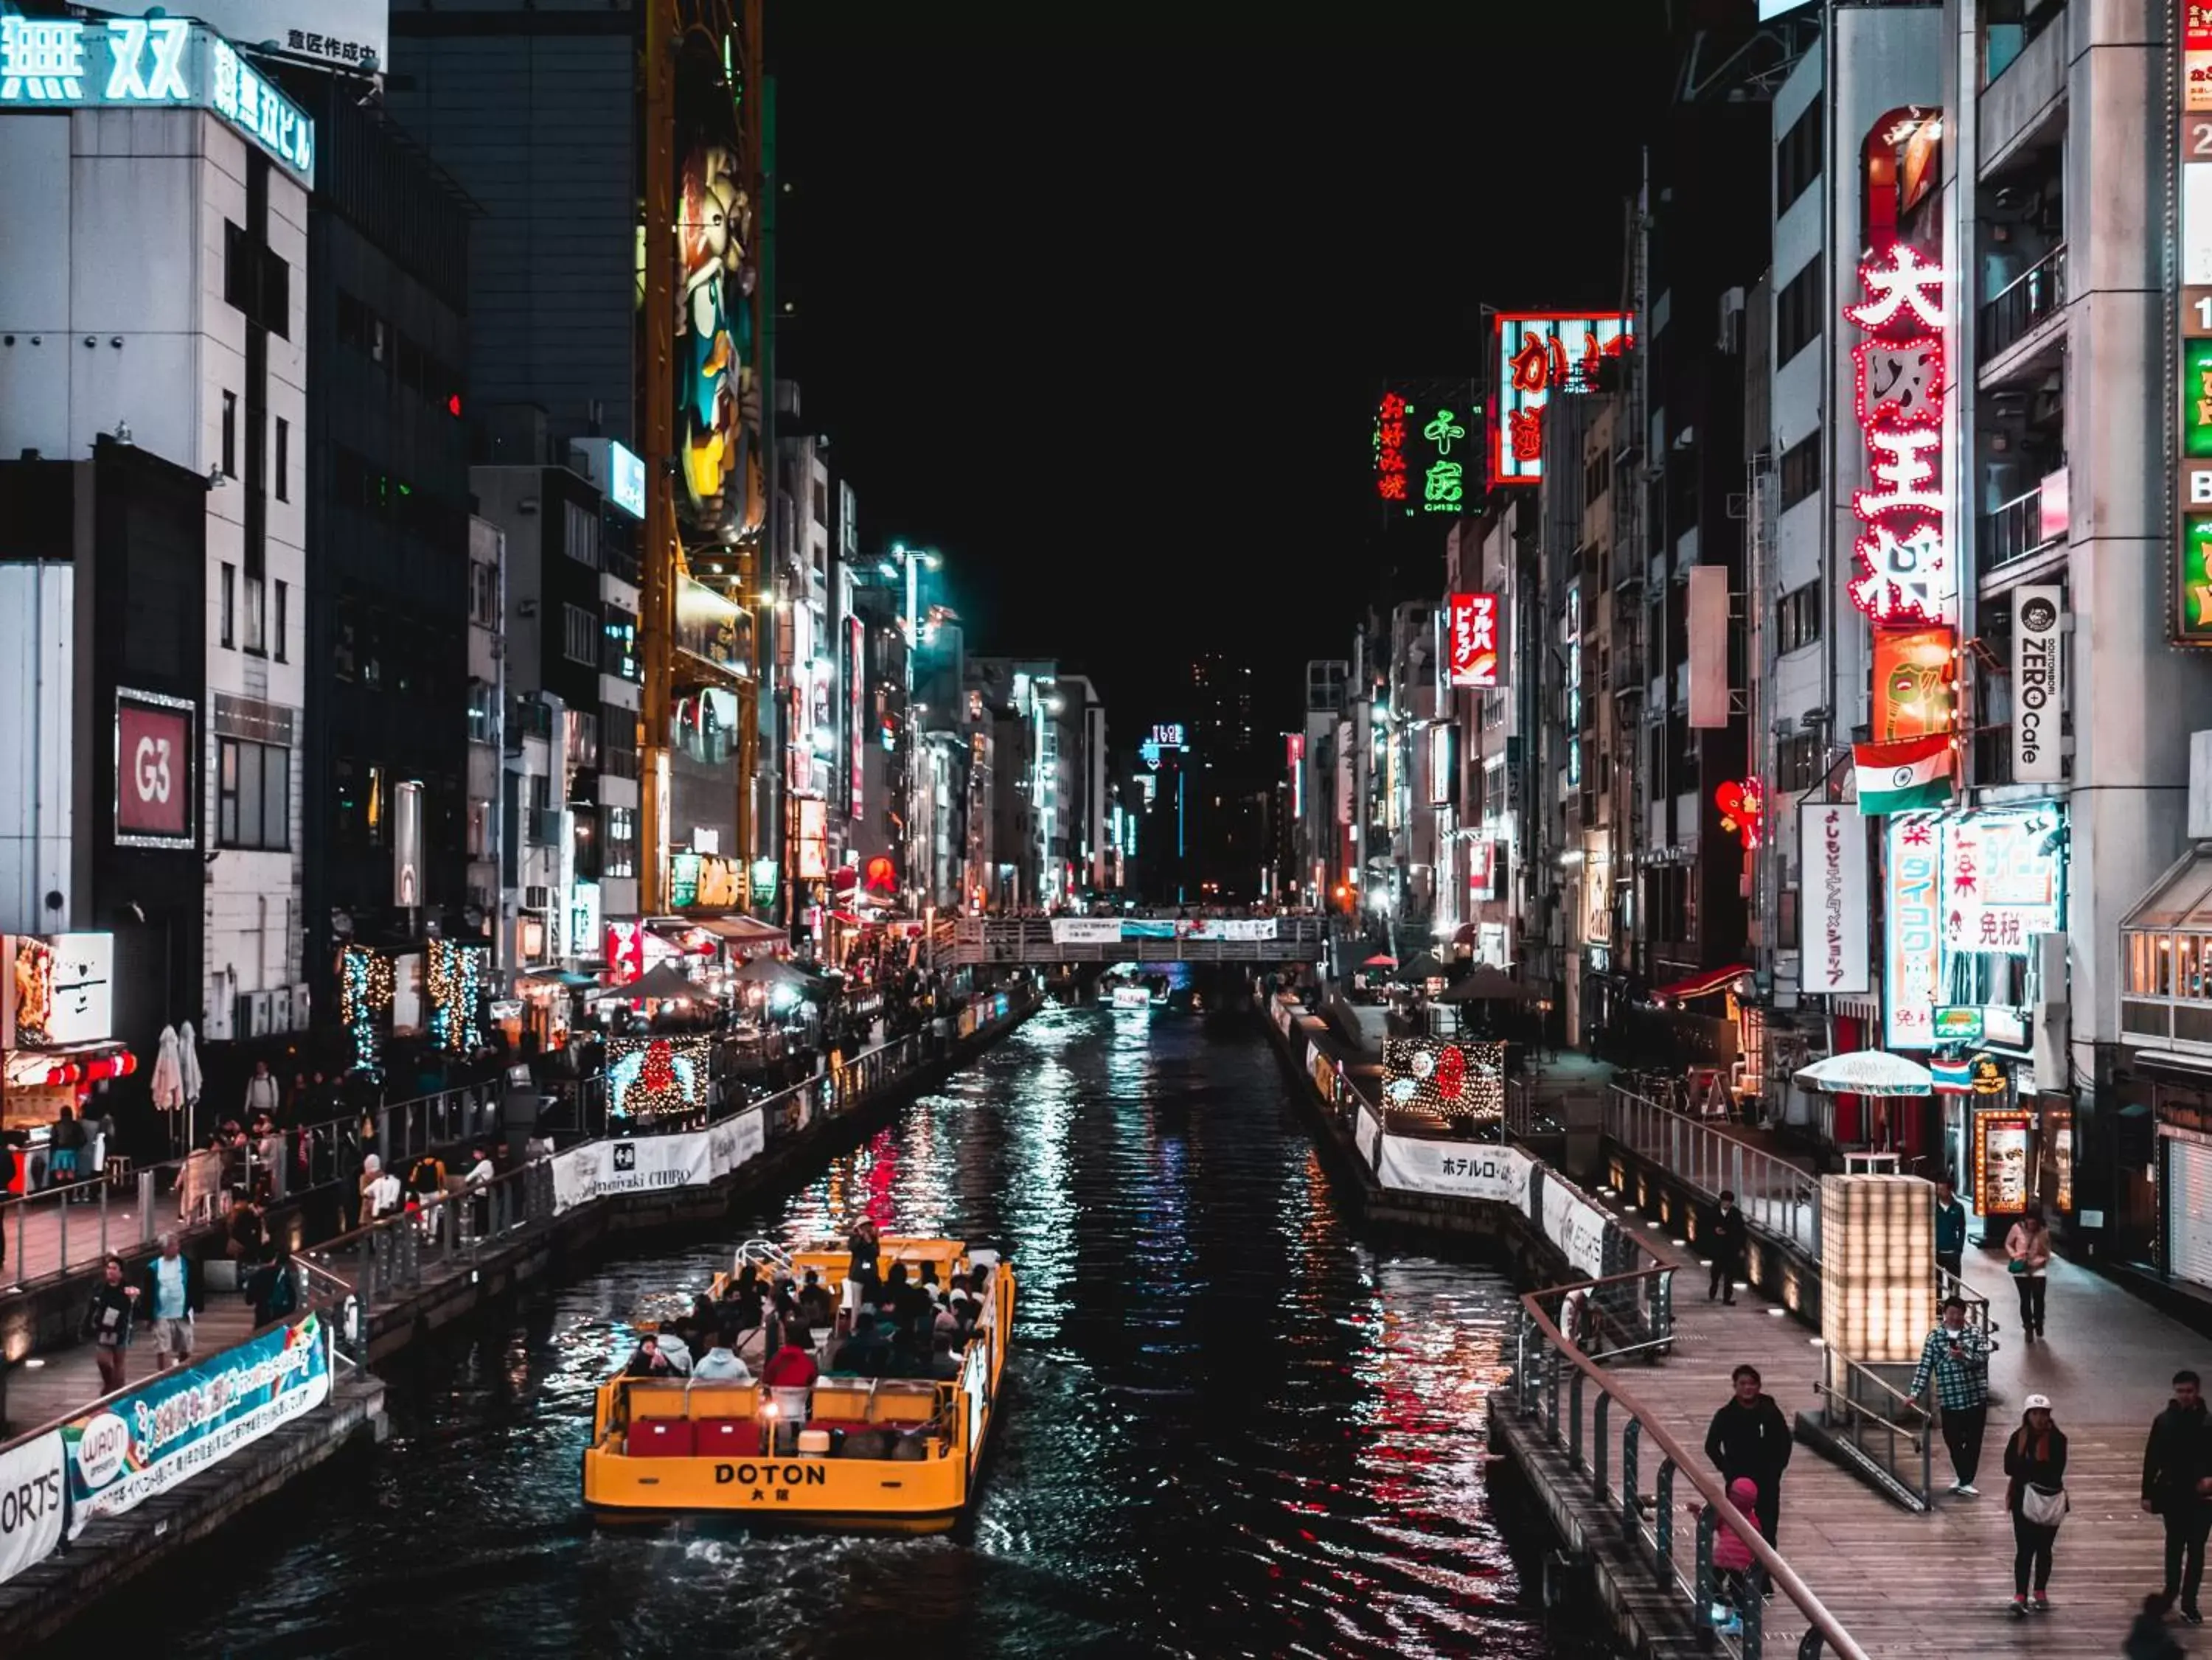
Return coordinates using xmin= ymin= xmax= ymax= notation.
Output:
xmin=675 ymin=15 xmax=765 ymax=537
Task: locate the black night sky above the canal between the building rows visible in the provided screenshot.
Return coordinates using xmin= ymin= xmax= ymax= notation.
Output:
xmin=770 ymin=0 xmax=1668 ymax=734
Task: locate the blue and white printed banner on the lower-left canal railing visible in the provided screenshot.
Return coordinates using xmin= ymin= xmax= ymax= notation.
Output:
xmin=62 ymin=1315 xmax=330 ymax=1538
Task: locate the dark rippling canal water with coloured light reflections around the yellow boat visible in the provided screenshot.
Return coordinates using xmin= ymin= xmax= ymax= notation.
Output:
xmin=66 ymin=1008 xmax=1599 ymax=1660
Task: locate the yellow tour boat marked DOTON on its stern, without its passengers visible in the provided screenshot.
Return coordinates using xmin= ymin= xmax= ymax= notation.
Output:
xmin=584 ymin=1238 xmax=1013 ymax=1534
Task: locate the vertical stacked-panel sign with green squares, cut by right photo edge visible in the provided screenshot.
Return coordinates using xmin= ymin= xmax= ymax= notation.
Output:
xmin=2177 ymin=0 xmax=2212 ymax=641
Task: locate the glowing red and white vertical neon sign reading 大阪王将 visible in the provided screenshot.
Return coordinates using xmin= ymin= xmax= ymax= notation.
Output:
xmin=1843 ymin=241 xmax=1958 ymax=624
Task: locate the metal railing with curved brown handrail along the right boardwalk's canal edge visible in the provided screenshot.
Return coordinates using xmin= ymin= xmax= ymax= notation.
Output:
xmin=1506 ymin=1273 xmax=1867 ymax=1660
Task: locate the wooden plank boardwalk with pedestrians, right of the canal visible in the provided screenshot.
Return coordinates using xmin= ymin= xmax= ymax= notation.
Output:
xmin=1562 ymin=1185 xmax=2212 ymax=1660
